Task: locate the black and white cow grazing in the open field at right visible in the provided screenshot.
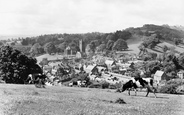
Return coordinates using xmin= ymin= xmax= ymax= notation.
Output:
xmin=121 ymin=77 xmax=157 ymax=97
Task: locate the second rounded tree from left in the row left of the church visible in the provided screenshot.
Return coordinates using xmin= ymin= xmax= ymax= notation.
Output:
xmin=44 ymin=42 xmax=56 ymax=54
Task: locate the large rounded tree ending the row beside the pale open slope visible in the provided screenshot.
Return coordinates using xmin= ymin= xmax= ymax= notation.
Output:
xmin=112 ymin=39 xmax=128 ymax=51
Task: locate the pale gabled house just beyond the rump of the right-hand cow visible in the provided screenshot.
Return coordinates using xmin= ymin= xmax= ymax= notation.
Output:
xmin=154 ymin=70 xmax=167 ymax=83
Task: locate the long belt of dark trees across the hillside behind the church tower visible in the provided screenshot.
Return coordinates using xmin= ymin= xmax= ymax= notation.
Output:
xmin=0 ymin=24 xmax=181 ymax=55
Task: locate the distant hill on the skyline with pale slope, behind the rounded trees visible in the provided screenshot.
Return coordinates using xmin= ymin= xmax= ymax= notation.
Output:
xmin=0 ymin=24 xmax=184 ymax=53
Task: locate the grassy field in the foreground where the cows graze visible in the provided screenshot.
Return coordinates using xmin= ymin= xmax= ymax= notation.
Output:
xmin=0 ymin=84 xmax=184 ymax=115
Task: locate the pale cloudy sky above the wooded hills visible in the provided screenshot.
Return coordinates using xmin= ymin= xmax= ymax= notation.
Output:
xmin=0 ymin=0 xmax=184 ymax=35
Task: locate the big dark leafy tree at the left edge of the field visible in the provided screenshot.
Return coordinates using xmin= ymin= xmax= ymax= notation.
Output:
xmin=0 ymin=46 xmax=42 ymax=84
